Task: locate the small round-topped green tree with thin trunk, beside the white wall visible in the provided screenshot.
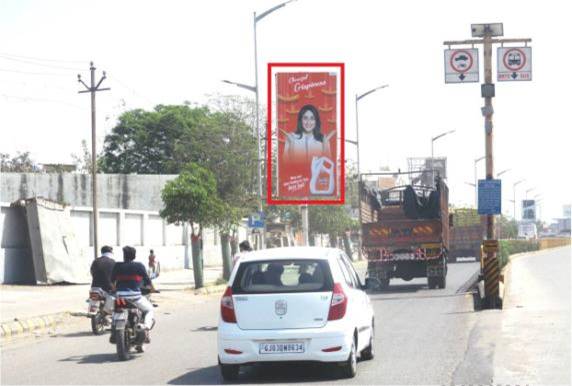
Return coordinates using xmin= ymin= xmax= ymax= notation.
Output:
xmin=160 ymin=163 xmax=222 ymax=288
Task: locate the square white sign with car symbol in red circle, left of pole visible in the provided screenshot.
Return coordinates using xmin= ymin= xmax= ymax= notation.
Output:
xmin=445 ymin=48 xmax=479 ymax=83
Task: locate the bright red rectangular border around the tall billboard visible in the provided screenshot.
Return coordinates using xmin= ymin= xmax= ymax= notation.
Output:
xmin=266 ymin=62 xmax=346 ymax=205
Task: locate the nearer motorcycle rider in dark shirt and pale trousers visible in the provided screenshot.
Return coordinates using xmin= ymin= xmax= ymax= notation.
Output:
xmin=111 ymin=246 xmax=157 ymax=343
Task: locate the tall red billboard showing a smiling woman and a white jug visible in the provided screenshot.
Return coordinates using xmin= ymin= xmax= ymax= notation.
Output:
xmin=266 ymin=63 xmax=344 ymax=205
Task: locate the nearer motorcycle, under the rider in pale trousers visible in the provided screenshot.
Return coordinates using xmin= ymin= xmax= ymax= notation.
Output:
xmin=110 ymin=288 xmax=159 ymax=361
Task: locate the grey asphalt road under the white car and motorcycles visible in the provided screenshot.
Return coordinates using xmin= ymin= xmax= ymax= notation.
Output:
xmin=1 ymin=262 xmax=493 ymax=384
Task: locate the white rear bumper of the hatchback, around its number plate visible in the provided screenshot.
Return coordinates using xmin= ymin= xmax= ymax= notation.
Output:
xmin=218 ymin=322 xmax=353 ymax=364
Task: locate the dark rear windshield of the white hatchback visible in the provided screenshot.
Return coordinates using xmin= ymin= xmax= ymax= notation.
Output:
xmin=232 ymin=259 xmax=334 ymax=294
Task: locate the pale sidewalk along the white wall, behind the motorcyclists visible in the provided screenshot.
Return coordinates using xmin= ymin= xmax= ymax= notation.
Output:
xmin=0 ymin=266 xmax=222 ymax=335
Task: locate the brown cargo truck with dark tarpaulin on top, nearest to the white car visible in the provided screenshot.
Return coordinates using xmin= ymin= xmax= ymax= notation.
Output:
xmin=360 ymin=177 xmax=450 ymax=290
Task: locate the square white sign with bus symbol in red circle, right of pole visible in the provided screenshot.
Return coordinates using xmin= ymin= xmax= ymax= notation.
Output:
xmin=497 ymin=47 xmax=532 ymax=82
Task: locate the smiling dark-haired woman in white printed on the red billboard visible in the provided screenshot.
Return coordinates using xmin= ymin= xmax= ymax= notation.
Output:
xmin=281 ymin=105 xmax=336 ymax=163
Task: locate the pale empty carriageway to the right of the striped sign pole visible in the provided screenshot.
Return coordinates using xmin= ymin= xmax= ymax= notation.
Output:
xmin=493 ymin=247 xmax=571 ymax=385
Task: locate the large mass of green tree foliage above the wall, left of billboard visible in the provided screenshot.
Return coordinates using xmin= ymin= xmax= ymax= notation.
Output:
xmin=99 ymin=97 xmax=258 ymax=232
